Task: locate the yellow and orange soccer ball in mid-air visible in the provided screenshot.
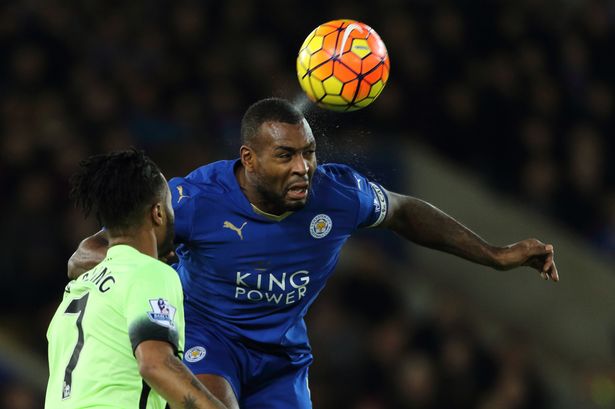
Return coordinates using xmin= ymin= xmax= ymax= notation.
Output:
xmin=297 ymin=20 xmax=390 ymax=111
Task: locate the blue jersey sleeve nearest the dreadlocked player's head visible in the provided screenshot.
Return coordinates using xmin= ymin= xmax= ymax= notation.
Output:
xmin=169 ymin=178 xmax=197 ymax=243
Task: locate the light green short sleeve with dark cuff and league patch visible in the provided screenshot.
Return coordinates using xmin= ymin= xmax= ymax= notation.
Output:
xmin=126 ymin=261 xmax=184 ymax=354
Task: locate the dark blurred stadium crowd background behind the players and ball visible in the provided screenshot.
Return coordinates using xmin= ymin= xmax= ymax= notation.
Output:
xmin=0 ymin=0 xmax=615 ymax=409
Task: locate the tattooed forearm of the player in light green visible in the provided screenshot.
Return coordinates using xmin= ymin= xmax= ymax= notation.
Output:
xmin=142 ymin=354 xmax=226 ymax=409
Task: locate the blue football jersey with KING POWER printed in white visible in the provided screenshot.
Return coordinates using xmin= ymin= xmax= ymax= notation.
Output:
xmin=169 ymin=160 xmax=388 ymax=352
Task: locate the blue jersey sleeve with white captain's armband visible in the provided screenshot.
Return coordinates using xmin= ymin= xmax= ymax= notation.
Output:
xmin=326 ymin=165 xmax=388 ymax=227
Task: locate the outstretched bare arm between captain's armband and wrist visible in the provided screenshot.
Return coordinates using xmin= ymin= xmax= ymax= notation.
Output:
xmin=385 ymin=194 xmax=500 ymax=268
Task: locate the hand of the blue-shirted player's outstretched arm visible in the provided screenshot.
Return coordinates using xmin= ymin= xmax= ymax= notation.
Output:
xmin=496 ymin=239 xmax=559 ymax=281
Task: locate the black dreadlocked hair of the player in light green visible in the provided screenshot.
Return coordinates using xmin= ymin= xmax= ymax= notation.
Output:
xmin=70 ymin=148 xmax=165 ymax=231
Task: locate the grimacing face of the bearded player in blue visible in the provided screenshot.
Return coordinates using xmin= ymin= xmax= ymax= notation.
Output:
xmin=254 ymin=119 xmax=316 ymax=212
